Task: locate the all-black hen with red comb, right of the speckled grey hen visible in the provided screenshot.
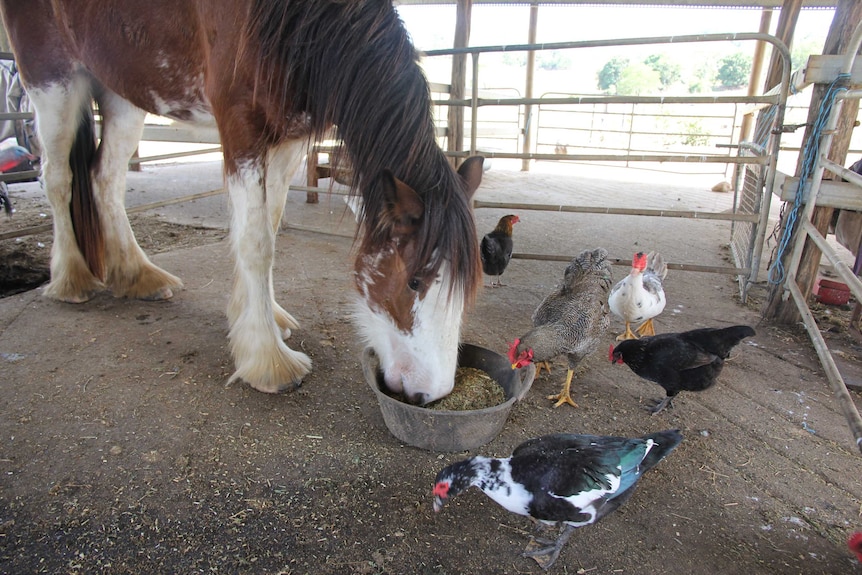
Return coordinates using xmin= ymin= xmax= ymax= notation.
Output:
xmin=610 ymin=325 xmax=755 ymax=415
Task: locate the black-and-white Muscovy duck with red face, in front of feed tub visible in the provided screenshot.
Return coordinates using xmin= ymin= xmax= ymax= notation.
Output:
xmin=433 ymin=429 xmax=682 ymax=569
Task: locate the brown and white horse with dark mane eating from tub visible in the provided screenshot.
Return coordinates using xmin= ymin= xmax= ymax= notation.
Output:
xmin=2 ymin=0 xmax=482 ymax=403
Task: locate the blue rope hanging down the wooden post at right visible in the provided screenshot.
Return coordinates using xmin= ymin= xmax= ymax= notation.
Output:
xmin=769 ymin=74 xmax=850 ymax=285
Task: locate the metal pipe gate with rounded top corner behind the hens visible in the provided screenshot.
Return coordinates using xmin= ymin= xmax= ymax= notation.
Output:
xmin=423 ymin=33 xmax=790 ymax=299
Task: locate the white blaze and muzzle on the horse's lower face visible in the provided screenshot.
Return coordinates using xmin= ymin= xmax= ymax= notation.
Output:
xmin=355 ymin=263 xmax=464 ymax=403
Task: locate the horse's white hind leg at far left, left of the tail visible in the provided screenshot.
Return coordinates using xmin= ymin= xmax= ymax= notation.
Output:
xmin=28 ymin=78 xmax=104 ymax=303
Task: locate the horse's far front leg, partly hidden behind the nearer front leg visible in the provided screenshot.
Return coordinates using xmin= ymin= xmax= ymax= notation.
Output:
xmin=266 ymin=140 xmax=308 ymax=339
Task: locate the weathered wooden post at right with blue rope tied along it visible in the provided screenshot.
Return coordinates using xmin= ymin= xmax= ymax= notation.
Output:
xmin=764 ymin=0 xmax=862 ymax=323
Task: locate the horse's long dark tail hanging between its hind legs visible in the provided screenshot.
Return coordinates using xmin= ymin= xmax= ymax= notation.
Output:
xmin=69 ymin=102 xmax=105 ymax=280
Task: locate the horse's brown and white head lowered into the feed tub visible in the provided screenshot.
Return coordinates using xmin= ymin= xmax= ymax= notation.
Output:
xmin=355 ymin=157 xmax=482 ymax=405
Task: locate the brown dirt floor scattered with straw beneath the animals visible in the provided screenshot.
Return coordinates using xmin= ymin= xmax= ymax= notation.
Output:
xmin=0 ymin=159 xmax=862 ymax=575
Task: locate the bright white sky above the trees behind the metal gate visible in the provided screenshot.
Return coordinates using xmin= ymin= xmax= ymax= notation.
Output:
xmin=397 ymin=4 xmax=834 ymax=93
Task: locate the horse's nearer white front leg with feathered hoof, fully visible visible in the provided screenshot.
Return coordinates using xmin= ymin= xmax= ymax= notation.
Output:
xmin=226 ymin=158 xmax=311 ymax=393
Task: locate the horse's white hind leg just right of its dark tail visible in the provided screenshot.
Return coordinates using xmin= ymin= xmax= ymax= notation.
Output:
xmin=93 ymin=90 xmax=182 ymax=299
